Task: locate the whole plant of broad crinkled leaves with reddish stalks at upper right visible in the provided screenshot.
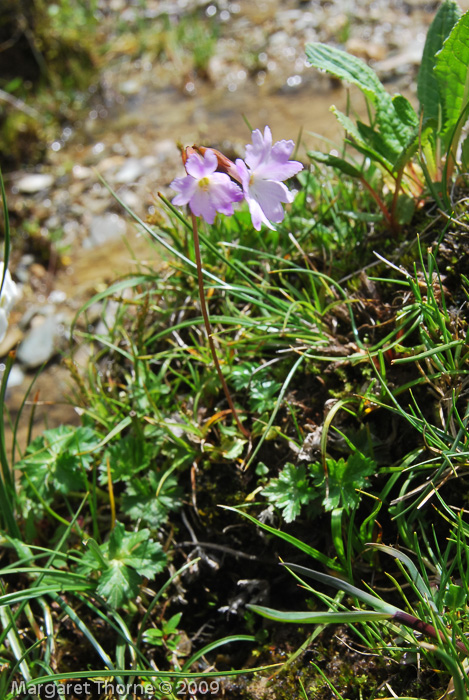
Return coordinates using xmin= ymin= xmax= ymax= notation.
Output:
xmin=306 ymin=0 xmax=469 ymax=230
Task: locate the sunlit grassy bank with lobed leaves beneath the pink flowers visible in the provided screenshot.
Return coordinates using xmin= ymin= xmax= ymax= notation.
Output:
xmin=4 ymin=3 xmax=469 ymax=700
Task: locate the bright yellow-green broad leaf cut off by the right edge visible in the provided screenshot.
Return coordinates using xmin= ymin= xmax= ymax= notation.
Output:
xmin=434 ymin=12 xmax=469 ymax=147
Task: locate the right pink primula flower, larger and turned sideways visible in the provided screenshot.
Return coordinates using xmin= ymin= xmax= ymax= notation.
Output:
xmin=236 ymin=126 xmax=303 ymax=231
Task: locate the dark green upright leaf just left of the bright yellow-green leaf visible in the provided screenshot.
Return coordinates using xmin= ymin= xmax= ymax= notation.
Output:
xmin=417 ymin=0 xmax=461 ymax=124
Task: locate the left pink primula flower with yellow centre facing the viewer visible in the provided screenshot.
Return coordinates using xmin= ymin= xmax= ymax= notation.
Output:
xmin=170 ymin=148 xmax=243 ymax=224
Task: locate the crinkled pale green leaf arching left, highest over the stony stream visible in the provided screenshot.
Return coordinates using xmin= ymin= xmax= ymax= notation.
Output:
xmin=306 ymin=43 xmax=409 ymax=157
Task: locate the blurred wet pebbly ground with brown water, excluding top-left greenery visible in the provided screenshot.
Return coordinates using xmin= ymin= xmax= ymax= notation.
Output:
xmin=0 ymin=0 xmax=469 ymax=441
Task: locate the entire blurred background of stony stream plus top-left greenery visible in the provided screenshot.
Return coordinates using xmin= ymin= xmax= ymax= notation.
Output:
xmin=0 ymin=0 xmax=469 ymax=432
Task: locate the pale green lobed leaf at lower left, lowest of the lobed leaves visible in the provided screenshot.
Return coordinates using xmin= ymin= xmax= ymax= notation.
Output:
xmin=78 ymin=523 xmax=166 ymax=608
